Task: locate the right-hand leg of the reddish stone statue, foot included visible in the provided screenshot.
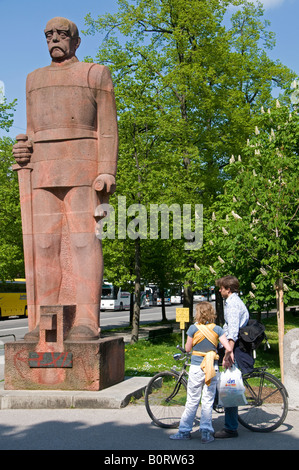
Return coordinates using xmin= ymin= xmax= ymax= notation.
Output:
xmin=64 ymin=186 xmax=103 ymax=341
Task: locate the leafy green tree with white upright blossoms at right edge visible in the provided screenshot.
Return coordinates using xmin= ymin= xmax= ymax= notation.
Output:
xmin=198 ymin=101 xmax=299 ymax=312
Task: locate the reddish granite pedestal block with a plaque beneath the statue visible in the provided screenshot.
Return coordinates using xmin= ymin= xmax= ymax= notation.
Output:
xmin=5 ymin=306 xmax=125 ymax=391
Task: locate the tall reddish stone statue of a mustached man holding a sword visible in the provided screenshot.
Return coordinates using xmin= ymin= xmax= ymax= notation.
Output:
xmin=13 ymin=17 xmax=118 ymax=341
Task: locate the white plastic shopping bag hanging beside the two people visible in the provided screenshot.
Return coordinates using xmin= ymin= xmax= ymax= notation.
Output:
xmin=217 ymin=366 xmax=247 ymax=408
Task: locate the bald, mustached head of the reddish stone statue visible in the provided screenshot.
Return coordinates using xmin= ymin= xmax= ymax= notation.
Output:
xmin=44 ymin=17 xmax=81 ymax=62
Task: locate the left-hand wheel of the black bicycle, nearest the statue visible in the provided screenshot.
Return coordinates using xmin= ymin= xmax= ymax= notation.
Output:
xmin=145 ymin=371 xmax=187 ymax=428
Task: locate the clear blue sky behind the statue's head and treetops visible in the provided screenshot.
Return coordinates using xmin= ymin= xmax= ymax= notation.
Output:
xmin=0 ymin=0 xmax=299 ymax=137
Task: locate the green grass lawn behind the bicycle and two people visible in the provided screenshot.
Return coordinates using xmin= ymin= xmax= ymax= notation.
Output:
xmin=125 ymin=312 xmax=299 ymax=378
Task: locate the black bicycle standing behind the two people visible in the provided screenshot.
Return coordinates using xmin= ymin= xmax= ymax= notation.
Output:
xmin=145 ymin=346 xmax=288 ymax=432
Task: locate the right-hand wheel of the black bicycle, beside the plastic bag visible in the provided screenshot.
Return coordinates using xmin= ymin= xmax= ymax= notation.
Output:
xmin=238 ymin=371 xmax=288 ymax=432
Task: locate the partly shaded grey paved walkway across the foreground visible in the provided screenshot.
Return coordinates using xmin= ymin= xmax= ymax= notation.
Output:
xmin=0 ymin=404 xmax=299 ymax=450
